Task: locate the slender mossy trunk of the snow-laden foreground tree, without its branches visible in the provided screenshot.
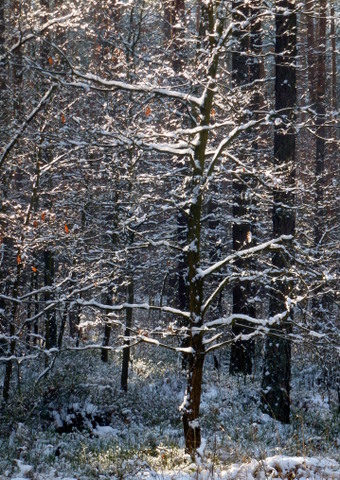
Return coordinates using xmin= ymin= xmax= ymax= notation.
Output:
xmin=182 ymin=2 xmax=223 ymax=459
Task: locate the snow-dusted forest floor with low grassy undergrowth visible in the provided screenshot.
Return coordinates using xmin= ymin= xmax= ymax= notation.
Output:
xmin=0 ymin=346 xmax=340 ymax=480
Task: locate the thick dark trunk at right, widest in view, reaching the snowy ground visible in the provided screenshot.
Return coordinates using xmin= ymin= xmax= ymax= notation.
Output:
xmin=262 ymin=0 xmax=296 ymax=423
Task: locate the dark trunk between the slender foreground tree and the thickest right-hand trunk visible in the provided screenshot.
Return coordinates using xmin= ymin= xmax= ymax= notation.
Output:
xmin=229 ymin=0 xmax=261 ymax=375
